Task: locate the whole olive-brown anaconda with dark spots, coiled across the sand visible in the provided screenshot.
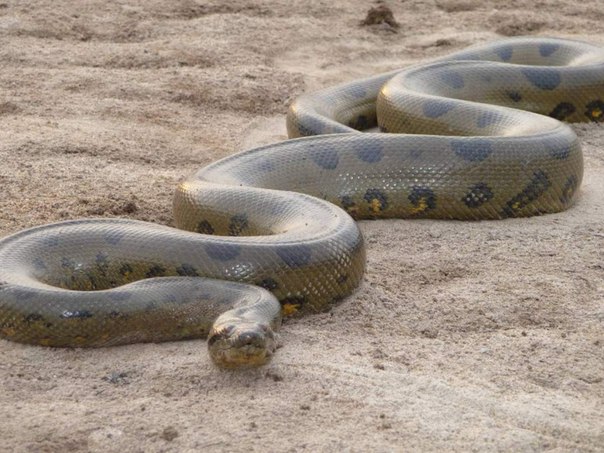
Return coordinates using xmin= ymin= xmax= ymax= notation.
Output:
xmin=0 ymin=38 xmax=604 ymax=367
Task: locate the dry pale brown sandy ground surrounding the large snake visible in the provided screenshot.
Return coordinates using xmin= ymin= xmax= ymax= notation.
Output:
xmin=0 ymin=0 xmax=604 ymax=452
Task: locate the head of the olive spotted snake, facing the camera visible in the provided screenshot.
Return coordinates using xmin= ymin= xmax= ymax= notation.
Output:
xmin=208 ymin=321 xmax=277 ymax=368
